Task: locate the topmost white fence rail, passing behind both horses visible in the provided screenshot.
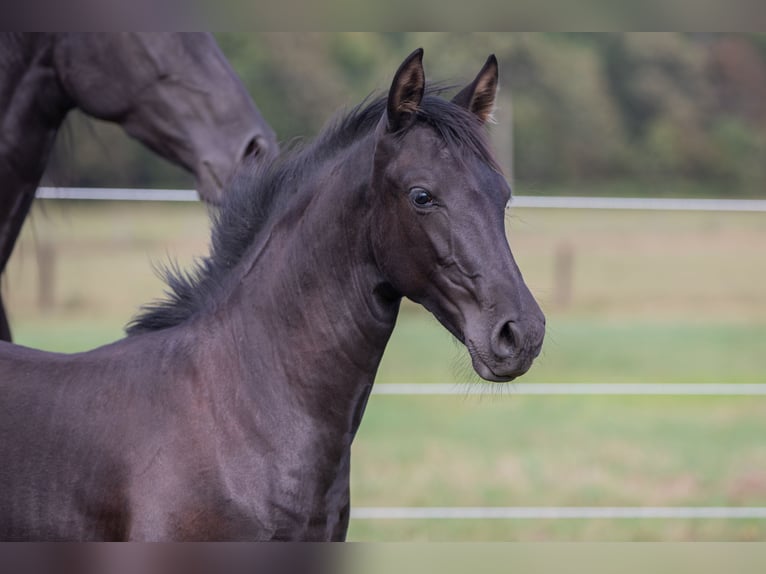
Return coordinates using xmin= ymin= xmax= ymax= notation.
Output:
xmin=37 ymin=187 xmax=766 ymax=212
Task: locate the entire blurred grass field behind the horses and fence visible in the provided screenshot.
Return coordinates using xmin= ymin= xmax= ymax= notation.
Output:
xmin=3 ymin=202 xmax=766 ymax=541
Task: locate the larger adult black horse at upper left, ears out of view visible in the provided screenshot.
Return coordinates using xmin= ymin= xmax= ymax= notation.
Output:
xmin=0 ymin=32 xmax=277 ymax=341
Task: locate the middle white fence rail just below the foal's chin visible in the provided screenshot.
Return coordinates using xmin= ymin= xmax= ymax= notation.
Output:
xmin=372 ymin=383 xmax=766 ymax=397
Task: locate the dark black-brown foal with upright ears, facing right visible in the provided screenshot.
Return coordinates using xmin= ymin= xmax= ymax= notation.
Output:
xmin=0 ymin=50 xmax=545 ymax=540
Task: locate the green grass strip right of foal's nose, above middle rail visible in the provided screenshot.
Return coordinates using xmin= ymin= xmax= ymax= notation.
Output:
xmin=530 ymin=319 xmax=766 ymax=383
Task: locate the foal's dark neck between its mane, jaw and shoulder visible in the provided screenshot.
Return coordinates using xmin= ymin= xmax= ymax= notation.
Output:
xmin=214 ymin=137 xmax=399 ymax=436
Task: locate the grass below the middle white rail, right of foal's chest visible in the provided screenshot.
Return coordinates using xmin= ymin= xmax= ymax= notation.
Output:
xmin=351 ymin=396 xmax=766 ymax=540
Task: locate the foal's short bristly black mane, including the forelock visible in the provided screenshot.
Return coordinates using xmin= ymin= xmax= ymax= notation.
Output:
xmin=126 ymin=86 xmax=501 ymax=336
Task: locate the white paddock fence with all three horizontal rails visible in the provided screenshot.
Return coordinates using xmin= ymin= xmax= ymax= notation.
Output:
xmin=36 ymin=187 xmax=766 ymax=520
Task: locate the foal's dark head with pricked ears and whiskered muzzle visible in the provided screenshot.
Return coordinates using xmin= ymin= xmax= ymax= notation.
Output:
xmin=372 ymin=50 xmax=545 ymax=381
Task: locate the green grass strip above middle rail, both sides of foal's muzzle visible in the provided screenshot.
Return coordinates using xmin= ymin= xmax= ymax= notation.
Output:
xmin=377 ymin=307 xmax=766 ymax=383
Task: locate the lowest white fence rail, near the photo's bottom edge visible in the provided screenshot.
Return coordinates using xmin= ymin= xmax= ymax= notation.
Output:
xmin=351 ymin=506 xmax=766 ymax=520
